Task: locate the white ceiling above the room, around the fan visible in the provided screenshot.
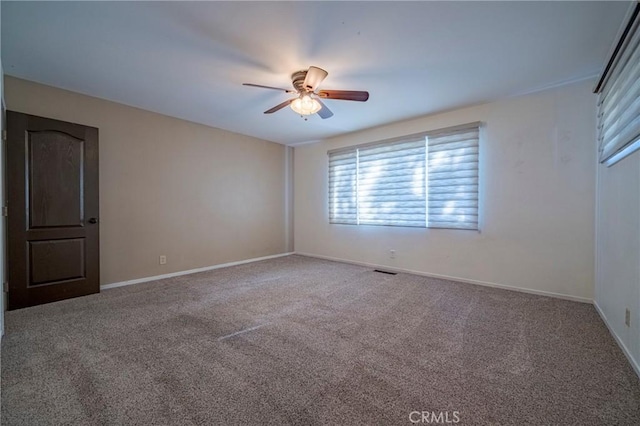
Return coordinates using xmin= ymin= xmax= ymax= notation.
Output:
xmin=2 ymin=1 xmax=629 ymax=144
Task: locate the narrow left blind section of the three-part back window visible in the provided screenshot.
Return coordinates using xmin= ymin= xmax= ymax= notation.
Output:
xmin=329 ymin=149 xmax=358 ymax=225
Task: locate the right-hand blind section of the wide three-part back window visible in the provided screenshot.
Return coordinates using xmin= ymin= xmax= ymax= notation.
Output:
xmin=427 ymin=127 xmax=478 ymax=229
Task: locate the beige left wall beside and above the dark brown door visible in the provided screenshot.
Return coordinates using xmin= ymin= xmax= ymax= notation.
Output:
xmin=5 ymin=76 xmax=287 ymax=285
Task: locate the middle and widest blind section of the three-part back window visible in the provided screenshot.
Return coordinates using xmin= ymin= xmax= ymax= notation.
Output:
xmin=358 ymin=137 xmax=426 ymax=228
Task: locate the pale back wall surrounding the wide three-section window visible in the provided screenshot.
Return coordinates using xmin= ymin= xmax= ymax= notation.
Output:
xmin=294 ymin=81 xmax=596 ymax=300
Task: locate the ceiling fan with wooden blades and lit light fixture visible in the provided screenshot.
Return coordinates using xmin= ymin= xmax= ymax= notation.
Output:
xmin=242 ymin=66 xmax=369 ymax=119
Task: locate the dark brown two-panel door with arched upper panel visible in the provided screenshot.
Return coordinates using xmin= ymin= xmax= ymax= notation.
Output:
xmin=7 ymin=111 xmax=100 ymax=309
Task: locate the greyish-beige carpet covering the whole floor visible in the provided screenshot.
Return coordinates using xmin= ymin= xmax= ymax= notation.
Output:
xmin=2 ymin=256 xmax=640 ymax=426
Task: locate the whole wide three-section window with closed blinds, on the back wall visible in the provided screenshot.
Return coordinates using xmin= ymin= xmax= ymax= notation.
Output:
xmin=329 ymin=123 xmax=479 ymax=229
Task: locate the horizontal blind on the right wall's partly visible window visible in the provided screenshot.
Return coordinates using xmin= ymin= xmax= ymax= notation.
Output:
xmin=598 ymin=7 xmax=640 ymax=166
